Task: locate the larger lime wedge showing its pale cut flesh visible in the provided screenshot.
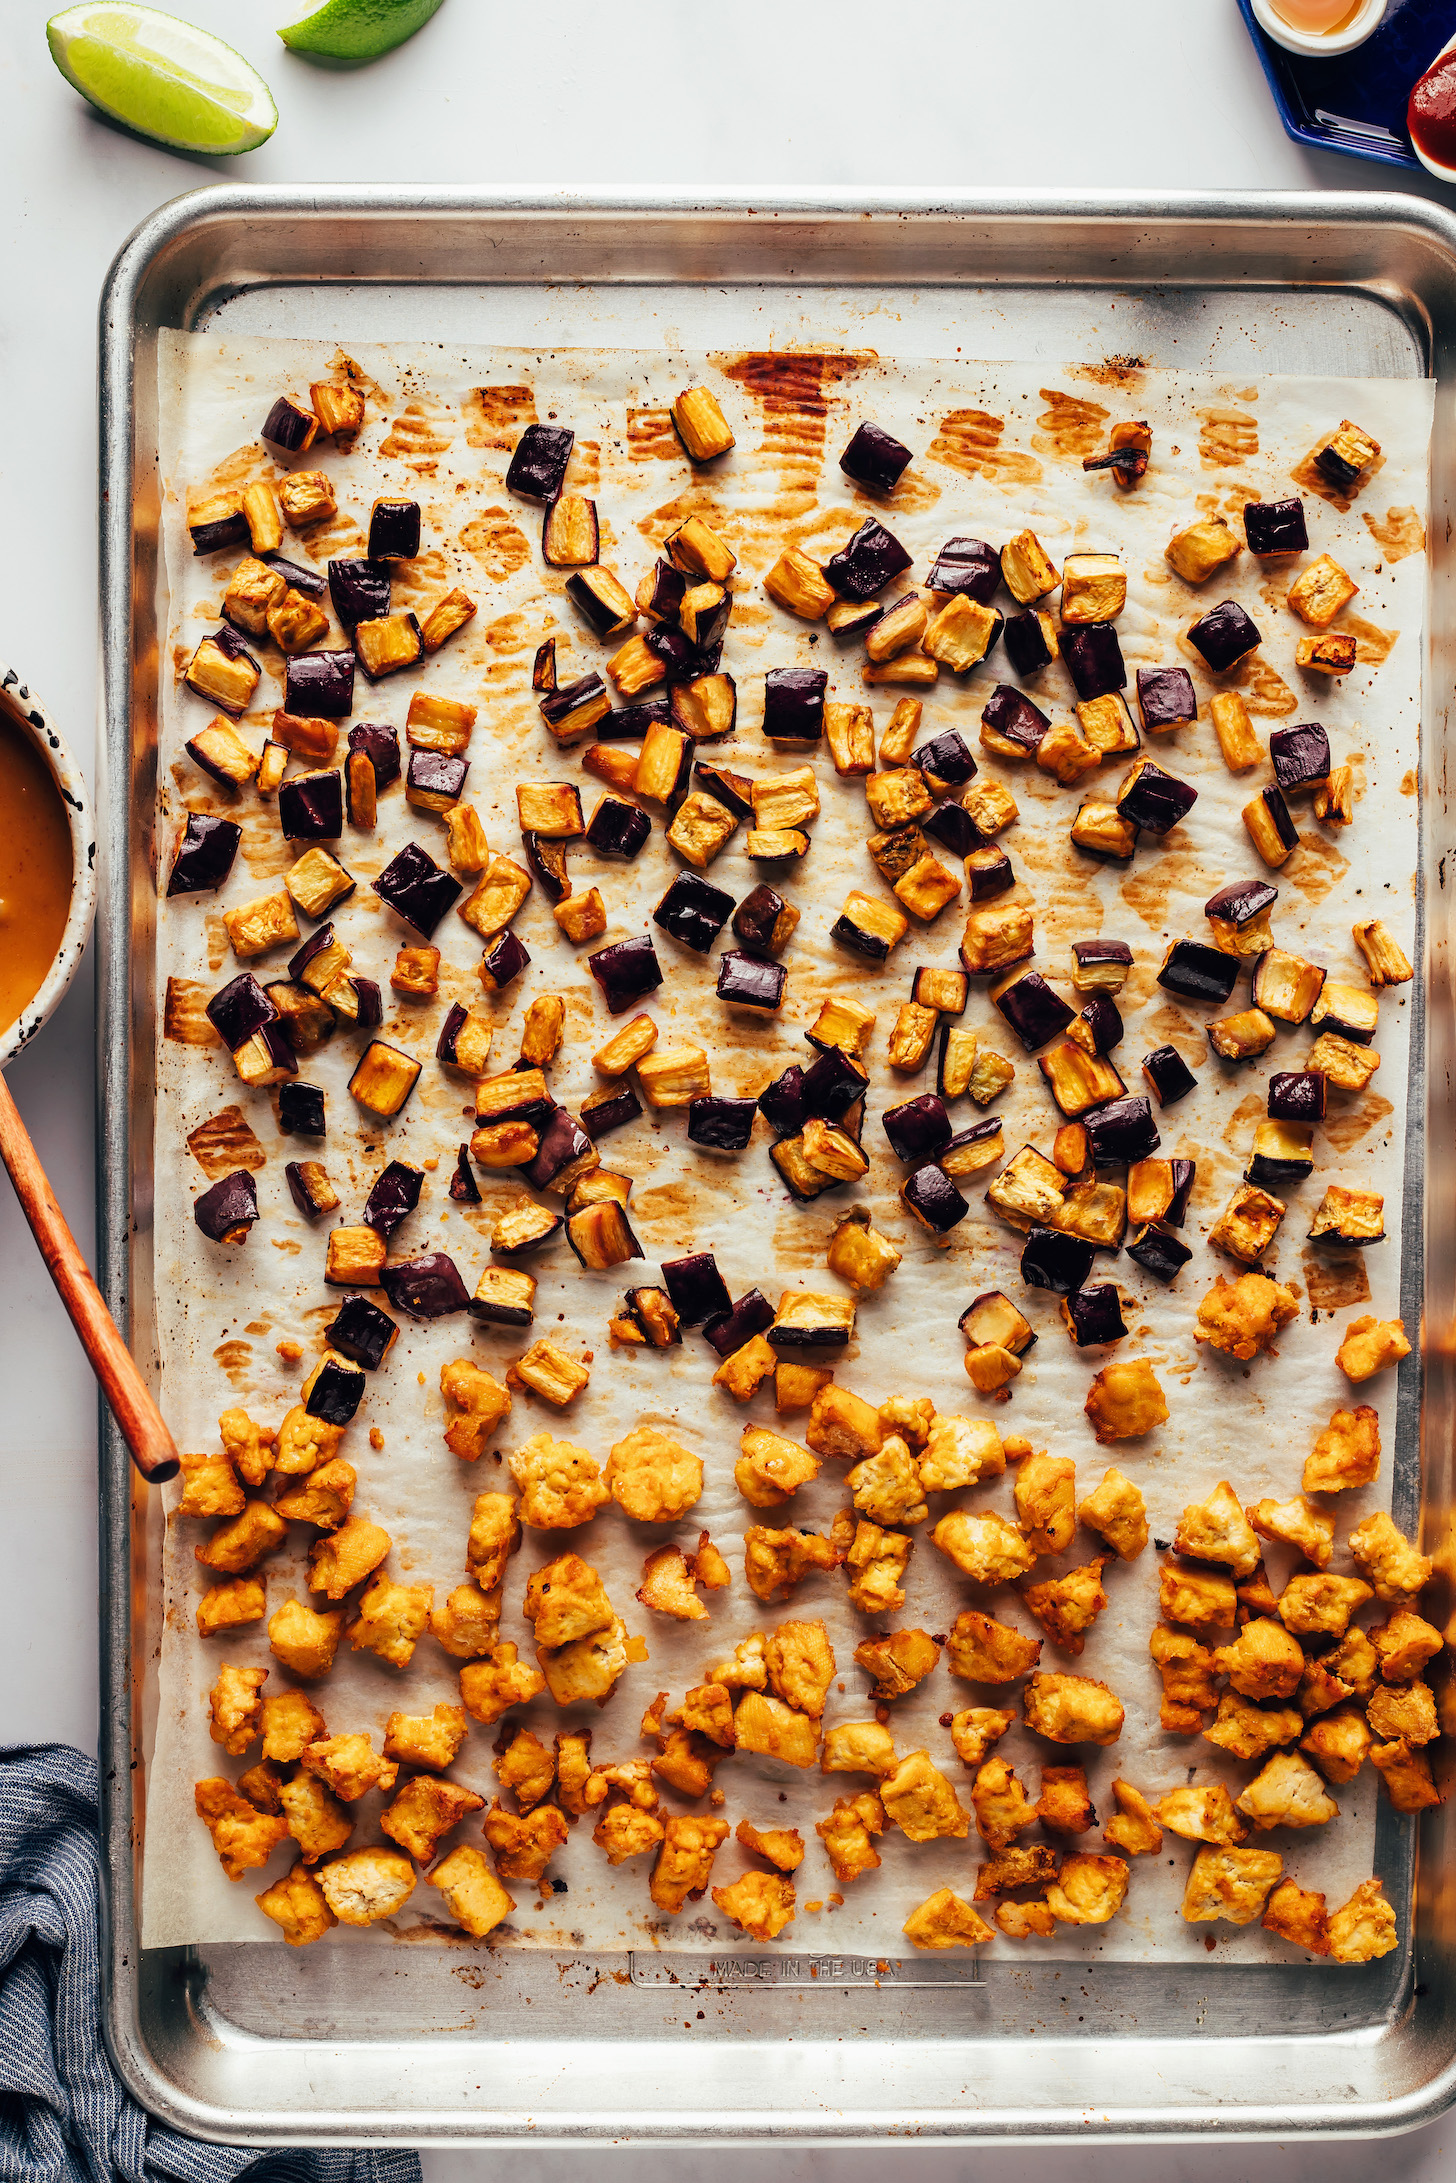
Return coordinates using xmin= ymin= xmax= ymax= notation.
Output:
xmin=46 ymin=0 xmax=277 ymax=153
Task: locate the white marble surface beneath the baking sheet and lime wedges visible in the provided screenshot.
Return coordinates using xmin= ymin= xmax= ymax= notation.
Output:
xmin=0 ymin=0 xmax=1456 ymax=2156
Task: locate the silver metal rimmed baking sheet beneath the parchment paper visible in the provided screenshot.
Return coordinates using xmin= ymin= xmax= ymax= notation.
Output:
xmin=100 ymin=190 xmax=1456 ymax=2144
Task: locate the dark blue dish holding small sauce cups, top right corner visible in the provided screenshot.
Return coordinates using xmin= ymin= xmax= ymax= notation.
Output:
xmin=1238 ymin=0 xmax=1456 ymax=175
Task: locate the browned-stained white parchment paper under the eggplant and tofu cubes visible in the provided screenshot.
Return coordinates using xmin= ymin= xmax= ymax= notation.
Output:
xmin=140 ymin=334 xmax=1432 ymax=1960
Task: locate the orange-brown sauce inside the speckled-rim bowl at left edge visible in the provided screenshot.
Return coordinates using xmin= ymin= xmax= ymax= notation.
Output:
xmin=0 ymin=714 xmax=74 ymax=1030
